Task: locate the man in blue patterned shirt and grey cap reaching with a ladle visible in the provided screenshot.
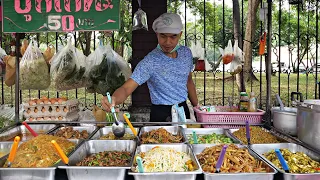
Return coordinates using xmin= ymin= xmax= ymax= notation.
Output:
xmin=102 ymin=13 xmax=198 ymax=122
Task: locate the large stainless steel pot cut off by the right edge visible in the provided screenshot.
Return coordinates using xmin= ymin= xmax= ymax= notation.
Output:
xmin=297 ymin=100 xmax=320 ymax=150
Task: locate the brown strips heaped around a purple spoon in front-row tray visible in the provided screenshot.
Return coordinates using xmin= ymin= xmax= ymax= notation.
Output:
xmin=197 ymin=144 xmax=269 ymax=173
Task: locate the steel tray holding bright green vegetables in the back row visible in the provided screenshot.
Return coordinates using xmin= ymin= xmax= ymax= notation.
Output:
xmin=183 ymin=128 xmax=240 ymax=145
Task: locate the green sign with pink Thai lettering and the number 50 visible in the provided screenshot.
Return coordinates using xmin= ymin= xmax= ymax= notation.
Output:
xmin=3 ymin=0 xmax=120 ymax=32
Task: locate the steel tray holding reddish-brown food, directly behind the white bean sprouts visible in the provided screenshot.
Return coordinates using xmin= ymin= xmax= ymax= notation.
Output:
xmin=139 ymin=126 xmax=187 ymax=144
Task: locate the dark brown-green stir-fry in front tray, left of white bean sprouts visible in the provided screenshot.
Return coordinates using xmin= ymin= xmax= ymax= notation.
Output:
xmin=76 ymin=151 xmax=131 ymax=167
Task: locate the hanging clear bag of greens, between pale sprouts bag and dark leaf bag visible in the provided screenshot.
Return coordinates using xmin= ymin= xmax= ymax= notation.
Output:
xmin=51 ymin=39 xmax=87 ymax=91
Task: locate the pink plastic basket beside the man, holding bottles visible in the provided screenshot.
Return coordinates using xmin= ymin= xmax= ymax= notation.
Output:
xmin=193 ymin=106 xmax=265 ymax=128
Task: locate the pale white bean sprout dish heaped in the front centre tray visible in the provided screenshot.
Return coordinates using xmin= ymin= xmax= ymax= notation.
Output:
xmin=133 ymin=146 xmax=196 ymax=172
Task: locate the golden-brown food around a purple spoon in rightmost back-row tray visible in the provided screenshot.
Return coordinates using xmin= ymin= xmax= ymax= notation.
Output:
xmin=233 ymin=126 xmax=279 ymax=144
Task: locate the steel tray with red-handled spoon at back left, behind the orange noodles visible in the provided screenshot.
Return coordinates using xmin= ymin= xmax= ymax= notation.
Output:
xmin=0 ymin=124 xmax=57 ymax=141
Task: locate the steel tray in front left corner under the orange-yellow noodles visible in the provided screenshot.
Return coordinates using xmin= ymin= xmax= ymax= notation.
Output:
xmin=0 ymin=139 xmax=82 ymax=180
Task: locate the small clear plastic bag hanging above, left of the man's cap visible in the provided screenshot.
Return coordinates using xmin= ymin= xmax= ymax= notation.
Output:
xmin=132 ymin=0 xmax=148 ymax=31
